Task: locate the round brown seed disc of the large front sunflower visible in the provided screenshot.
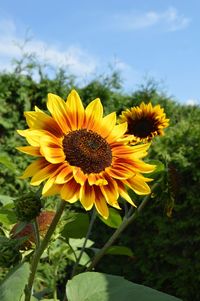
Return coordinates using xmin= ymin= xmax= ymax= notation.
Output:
xmin=63 ymin=129 xmax=112 ymax=174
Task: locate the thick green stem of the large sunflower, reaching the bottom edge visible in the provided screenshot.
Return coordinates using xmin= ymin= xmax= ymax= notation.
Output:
xmin=24 ymin=201 xmax=66 ymax=301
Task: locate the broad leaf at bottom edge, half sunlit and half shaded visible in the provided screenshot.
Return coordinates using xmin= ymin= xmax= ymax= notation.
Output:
xmin=67 ymin=272 xmax=180 ymax=301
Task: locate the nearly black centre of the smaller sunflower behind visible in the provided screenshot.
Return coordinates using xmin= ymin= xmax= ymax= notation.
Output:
xmin=128 ymin=118 xmax=156 ymax=138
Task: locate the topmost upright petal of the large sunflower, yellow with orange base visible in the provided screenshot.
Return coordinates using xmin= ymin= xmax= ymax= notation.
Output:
xmin=66 ymin=90 xmax=85 ymax=130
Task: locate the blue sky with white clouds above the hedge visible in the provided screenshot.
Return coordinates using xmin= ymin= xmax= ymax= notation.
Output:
xmin=0 ymin=0 xmax=200 ymax=104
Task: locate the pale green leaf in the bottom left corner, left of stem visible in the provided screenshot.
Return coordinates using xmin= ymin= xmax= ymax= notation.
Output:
xmin=0 ymin=262 xmax=29 ymax=301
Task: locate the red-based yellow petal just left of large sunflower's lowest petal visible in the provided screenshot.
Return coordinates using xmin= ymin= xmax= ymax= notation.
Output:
xmin=79 ymin=181 xmax=95 ymax=210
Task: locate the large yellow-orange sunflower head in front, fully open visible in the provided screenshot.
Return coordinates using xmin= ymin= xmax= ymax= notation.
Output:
xmin=17 ymin=90 xmax=155 ymax=218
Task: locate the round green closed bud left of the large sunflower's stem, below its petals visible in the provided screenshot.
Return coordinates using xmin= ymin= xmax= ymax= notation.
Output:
xmin=14 ymin=192 xmax=42 ymax=222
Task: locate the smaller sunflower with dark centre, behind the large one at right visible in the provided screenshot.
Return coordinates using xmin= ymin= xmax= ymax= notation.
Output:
xmin=119 ymin=102 xmax=169 ymax=142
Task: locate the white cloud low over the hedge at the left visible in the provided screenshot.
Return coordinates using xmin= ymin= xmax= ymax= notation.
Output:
xmin=0 ymin=19 xmax=98 ymax=77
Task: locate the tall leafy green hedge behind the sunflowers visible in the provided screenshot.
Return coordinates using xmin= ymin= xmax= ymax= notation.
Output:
xmin=0 ymin=57 xmax=200 ymax=301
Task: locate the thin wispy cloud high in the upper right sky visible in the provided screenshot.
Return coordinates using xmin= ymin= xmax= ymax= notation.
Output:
xmin=113 ymin=7 xmax=190 ymax=31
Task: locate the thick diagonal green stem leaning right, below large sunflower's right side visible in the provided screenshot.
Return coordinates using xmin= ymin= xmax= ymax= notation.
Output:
xmin=87 ymin=183 xmax=157 ymax=271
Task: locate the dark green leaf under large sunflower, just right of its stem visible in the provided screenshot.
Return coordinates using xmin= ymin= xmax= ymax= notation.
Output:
xmin=61 ymin=213 xmax=89 ymax=240
